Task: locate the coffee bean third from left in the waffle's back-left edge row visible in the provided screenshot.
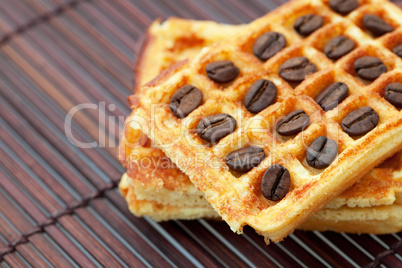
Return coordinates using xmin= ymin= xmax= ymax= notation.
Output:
xmin=253 ymin=32 xmax=286 ymax=61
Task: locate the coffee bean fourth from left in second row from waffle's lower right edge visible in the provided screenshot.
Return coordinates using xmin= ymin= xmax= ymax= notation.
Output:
xmin=354 ymin=56 xmax=388 ymax=81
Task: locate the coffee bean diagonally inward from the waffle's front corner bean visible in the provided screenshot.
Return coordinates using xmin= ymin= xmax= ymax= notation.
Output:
xmin=276 ymin=109 xmax=310 ymax=136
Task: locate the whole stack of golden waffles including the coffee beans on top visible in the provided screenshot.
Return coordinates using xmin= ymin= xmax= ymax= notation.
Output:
xmin=120 ymin=0 xmax=402 ymax=242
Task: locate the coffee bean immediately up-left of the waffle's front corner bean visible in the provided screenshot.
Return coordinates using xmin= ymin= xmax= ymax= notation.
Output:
xmin=226 ymin=146 xmax=265 ymax=173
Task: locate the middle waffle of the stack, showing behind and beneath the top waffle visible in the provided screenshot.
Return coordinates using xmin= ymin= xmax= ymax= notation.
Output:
xmin=125 ymin=18 xmax=402 ymax=208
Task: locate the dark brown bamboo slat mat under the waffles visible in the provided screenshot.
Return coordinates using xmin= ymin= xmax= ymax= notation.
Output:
xmin=0 ymin=0 xmax=402 ymax=267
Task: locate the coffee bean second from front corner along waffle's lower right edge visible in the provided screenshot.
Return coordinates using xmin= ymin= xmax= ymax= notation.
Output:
xmin=306 ymin=136 xmax=338 ymax=169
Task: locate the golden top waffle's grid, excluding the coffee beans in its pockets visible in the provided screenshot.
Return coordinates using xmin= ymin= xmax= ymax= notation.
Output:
xmin=124 ymin=1 xmax=401 ymax=241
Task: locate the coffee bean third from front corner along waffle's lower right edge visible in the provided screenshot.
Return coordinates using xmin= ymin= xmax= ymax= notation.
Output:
xmin=342 ymin=106 xmax=380 ymax=136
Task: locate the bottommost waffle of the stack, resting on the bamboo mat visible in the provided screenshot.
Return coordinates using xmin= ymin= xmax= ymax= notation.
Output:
xmin=119 ymin=174 xmax=402 ymax=234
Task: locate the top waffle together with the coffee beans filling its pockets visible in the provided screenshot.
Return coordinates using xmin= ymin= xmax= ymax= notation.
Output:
xmin=124 ymin=1 xmax=401 ymax=241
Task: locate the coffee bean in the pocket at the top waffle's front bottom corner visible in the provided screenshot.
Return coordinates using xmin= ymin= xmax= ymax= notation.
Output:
xmin=261 ymin=164 xmax=290 ymax=201
